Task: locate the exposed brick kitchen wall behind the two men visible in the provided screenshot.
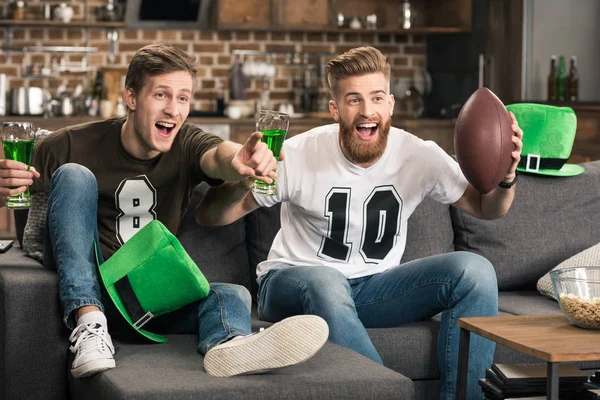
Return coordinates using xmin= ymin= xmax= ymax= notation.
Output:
xmin=0 ymin=0 xmax=426 ymax=112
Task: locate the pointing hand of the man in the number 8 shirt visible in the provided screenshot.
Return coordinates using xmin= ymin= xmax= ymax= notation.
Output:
xmin=231 ymin=132 xmax=284 ymax=183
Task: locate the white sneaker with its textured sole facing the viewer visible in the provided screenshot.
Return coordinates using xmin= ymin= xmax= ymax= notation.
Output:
xmin=204 ymin=315 xmax=329 ymax=377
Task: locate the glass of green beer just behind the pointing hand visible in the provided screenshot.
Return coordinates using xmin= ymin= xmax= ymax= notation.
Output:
xmin=252 ymin=110 xmax=290 ymax=195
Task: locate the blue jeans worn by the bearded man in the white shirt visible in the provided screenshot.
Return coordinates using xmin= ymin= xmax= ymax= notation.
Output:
xmin=258 ymin=252 xmax=498 ymax=399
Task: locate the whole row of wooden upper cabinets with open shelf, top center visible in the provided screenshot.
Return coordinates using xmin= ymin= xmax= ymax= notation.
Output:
xmin=216 ymin=0 xmax=473 ymax=34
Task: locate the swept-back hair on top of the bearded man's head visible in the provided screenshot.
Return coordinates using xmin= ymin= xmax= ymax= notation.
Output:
xmin=325 ymin=47 xmax=391 ymax=98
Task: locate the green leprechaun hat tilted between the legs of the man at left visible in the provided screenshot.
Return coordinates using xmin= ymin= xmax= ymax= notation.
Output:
xmin=99 ymin=220 xmax=209 ymax=342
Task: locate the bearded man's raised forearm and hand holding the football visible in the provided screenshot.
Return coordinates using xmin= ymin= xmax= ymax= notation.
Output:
xmin=453 ymin=112 xmax=523 ymax=219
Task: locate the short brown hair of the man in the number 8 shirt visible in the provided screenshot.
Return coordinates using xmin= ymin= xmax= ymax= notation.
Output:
xmin=125 ymin=43 xmax=198 ymax=93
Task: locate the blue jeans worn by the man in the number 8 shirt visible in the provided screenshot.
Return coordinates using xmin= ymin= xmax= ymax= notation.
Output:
xmin=44 ymin=164 xmax=252 ymax=354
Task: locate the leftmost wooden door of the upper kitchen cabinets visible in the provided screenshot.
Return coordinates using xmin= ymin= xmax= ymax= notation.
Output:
xmin=217 ymin=0 xmax=273 ymax=30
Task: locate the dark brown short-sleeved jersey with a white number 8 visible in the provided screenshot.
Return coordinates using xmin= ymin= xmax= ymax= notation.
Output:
xmin=31 ymin=118 xmax=222 ymax=259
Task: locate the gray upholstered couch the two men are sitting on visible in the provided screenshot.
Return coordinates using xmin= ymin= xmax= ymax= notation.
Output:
xmin=0 ymin=161 xmax=600 ymax=399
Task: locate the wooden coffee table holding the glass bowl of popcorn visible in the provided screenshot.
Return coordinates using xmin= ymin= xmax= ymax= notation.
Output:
xmin=456 ymin=314 xmax=600 ymax=400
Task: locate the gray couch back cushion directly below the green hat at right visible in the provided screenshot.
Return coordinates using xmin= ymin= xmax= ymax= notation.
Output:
xmin=451 ymin=161 xmax=600 ymax=290
